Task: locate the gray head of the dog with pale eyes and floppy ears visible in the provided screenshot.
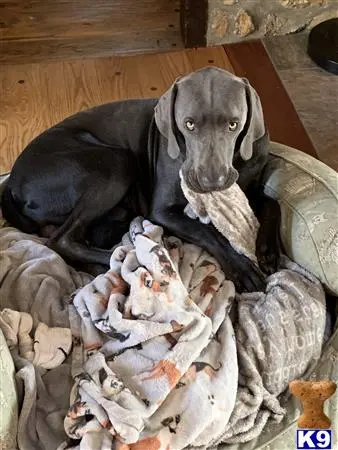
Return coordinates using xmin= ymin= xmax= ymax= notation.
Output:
xmin=155 ymin=67 xmax=265 ymax=192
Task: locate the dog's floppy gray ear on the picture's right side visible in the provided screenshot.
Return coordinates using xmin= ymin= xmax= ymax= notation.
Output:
xmin=239 ymin=78 xmax=265 ymax=161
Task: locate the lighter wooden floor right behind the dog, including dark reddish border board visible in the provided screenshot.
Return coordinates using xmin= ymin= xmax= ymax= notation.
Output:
xmin=0 ymin=42 xmax=315 ymax=173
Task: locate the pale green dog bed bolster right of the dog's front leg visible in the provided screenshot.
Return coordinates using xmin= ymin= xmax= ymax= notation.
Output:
xmin=263 ymin=143 xmax=338 ymax=296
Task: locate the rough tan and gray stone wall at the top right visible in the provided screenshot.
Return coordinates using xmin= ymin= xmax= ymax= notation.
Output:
xmin=207 ymin=0 xmax=338 ymax=45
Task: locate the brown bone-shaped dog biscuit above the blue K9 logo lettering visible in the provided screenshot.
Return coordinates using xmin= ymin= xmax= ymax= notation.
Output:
xmin=289 ymin=380 xmax=337 ymax=429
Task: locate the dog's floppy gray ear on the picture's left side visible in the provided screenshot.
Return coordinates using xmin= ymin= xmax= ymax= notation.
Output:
xmin=155 ymin=78 xmax=180 ymax=159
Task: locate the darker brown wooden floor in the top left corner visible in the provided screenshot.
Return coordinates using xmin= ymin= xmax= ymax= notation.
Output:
xmin=0 ymin=0 xmax=183 ymax=65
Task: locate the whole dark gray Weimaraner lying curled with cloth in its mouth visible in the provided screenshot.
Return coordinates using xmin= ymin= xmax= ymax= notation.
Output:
xmin=2 ymin=67 xmax=278 ymax=291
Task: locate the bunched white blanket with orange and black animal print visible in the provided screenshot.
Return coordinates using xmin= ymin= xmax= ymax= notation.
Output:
xmin=66 ymin=220 xmax=237 ymax=448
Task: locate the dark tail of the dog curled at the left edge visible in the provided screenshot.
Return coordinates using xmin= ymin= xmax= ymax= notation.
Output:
xmin=1 ymin=186 xmax=39 ymax=234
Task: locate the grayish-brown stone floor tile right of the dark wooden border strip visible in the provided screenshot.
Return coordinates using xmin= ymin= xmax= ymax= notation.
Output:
xmin=264 ymin=33 xmax=338 ymax=170
